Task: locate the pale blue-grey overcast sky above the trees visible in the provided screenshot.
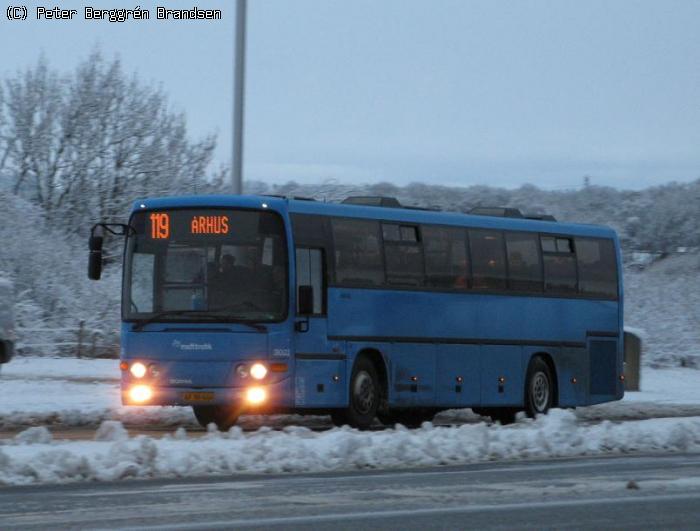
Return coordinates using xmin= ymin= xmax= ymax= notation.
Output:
xmin=0 ymin=0 xmax=700 ymax=188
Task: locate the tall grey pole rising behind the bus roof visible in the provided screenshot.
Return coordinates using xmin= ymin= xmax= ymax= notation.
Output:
xmin=231 ymin=0 xmax=247 ymax=194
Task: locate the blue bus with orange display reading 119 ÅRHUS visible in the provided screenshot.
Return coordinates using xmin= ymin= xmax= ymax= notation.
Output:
xmin=89 ymin=195 xmax=624 ymax=429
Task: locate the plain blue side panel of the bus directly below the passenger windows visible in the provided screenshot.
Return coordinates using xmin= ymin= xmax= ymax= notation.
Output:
xmin=328 ymin=288 xmax=618 ymax=347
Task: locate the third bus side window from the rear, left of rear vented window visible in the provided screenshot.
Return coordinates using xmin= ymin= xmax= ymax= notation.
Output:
xmin=506 ymin=232 xmax=542 ymax=291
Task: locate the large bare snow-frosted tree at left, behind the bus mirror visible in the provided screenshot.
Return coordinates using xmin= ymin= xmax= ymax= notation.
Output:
xmin=0 ymin=53 xmax=216 ymax=234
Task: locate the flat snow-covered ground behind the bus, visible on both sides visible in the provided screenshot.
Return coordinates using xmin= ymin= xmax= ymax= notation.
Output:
xmin=0 ymin=358 xmax=700 ymax=430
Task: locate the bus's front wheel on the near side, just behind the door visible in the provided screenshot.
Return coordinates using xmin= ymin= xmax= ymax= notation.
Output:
xmin=342 ymin=358 xmax=380 ymax=430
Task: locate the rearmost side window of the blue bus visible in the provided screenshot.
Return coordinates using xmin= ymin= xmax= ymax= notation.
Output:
xmin=576 ymin=238 xmax=617 ymax=299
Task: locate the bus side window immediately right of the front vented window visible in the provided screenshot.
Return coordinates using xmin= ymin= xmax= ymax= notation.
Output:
xmin=421 ymin=226 xmax=469 ymax=290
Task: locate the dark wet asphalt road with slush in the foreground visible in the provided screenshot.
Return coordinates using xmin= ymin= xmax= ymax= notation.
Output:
xmin=0 ymin=454 xmax=700 ymax=531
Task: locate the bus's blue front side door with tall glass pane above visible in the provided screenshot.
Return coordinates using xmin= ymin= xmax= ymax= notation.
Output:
xmin=294 ymin=247 xmax=347 ymax=408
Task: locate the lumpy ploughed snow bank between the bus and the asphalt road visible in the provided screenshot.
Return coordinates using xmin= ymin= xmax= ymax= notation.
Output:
xmin=0 ymin=410 xmax=700 ymax=485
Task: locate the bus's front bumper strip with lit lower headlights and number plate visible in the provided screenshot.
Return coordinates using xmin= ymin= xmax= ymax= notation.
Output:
xmin=122 ymin=378 xmax=294 ymax=411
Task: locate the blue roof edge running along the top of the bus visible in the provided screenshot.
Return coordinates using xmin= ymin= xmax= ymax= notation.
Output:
xmin=133 ymin=195 xmax=616 ymax=238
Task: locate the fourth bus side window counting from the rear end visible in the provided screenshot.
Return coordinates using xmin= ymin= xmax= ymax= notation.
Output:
xmin=469 ymin=230 xmax=506 ymax=290
